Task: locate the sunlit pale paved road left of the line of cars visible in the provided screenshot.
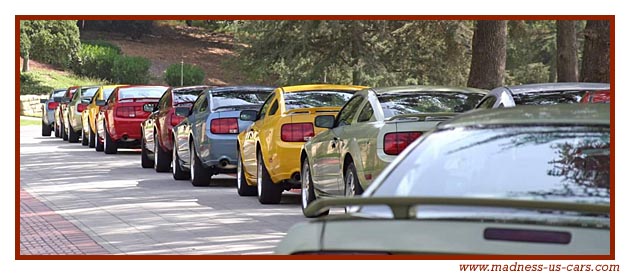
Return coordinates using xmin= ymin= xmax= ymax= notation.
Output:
xmin=20 ymin=126 xmax=320 ymax=255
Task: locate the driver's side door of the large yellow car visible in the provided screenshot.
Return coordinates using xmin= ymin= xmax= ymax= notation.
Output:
xmin=241 ymin=93 xmax=276 ymax=176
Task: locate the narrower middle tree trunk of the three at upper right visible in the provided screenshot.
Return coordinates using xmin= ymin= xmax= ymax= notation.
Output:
xmin=556 ymin=20 xmax=578 ymax=82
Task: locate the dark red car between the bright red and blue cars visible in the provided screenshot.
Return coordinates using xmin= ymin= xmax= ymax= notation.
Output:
xmin=140 ymin=86 xmax=210 ymax=172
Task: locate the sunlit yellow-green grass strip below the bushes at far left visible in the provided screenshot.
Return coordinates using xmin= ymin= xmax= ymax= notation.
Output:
xmin=20 ymin=69 xmax=104 ymax=95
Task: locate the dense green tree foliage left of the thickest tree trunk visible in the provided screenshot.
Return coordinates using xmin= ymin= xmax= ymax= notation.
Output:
xmin=235 ymin=20 xmax=472 ymax=86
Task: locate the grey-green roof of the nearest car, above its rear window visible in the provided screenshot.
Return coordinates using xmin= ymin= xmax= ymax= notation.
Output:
xmin=437 ymin=103 xmax=610 ymax=129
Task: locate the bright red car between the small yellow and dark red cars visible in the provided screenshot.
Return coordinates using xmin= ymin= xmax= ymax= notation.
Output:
xmin=96 ymin=85 xmax=169 ymax=154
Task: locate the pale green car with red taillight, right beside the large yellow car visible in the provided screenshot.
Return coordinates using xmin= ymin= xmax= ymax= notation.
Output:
xmin=300 ymin=86 xmax=487 ymax=217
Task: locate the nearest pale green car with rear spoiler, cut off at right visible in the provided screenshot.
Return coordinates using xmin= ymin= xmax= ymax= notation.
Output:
xmin=275 ymin=104 xmax=611 ymax=255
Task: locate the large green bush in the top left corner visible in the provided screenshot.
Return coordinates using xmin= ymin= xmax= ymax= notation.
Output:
xmin=20 ymin=20 xmax=80 ymax=68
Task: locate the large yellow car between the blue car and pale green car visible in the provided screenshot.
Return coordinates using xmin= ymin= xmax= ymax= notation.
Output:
xmin=237 ymin=84 xmax=366 ymax=204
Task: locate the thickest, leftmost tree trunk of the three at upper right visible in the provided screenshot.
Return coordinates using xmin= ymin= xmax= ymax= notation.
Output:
xmin=468 ymin=20 xmax=507 ymax=89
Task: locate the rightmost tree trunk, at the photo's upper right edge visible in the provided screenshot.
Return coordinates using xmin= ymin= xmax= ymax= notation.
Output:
xmin=580 ymin=20 xmax=610 ymax=83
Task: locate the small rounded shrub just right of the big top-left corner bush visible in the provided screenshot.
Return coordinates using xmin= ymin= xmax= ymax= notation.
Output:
xmin=72 ymin=43 xmax=120 ymax=81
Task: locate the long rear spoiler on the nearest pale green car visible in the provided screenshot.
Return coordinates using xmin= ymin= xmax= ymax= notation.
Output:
xmin=304 ymin=197 xmax=610 ymax=219
